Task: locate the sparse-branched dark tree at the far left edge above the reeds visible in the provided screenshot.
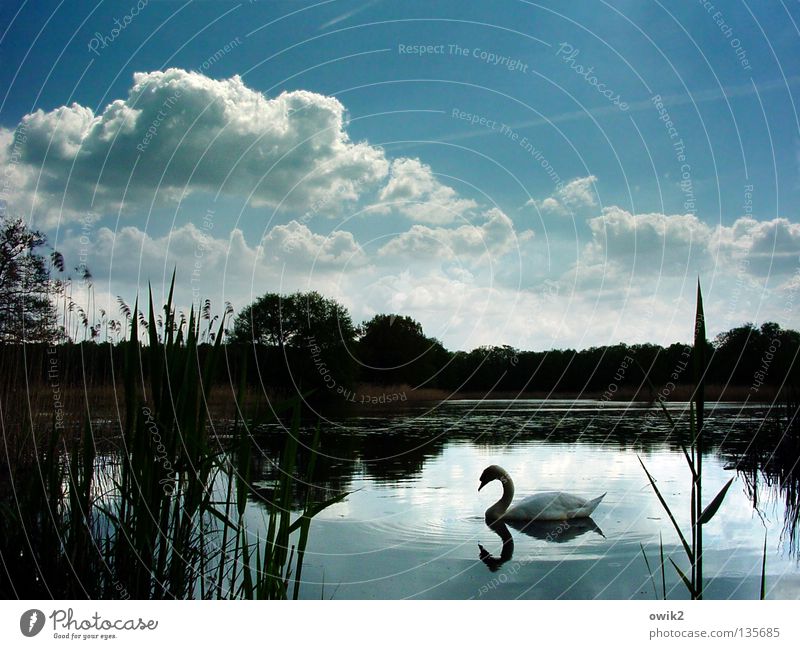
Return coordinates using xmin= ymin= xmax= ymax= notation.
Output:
xmin=0 ymin=217 xmax=63 ymax=343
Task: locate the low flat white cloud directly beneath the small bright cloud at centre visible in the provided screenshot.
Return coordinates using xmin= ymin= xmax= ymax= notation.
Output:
xmin=379 ymin=208 xmax=533 ymax=259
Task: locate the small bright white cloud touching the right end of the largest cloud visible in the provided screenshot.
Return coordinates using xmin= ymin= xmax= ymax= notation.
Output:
xmin=372 ymin=158 xmax=477 ymax=224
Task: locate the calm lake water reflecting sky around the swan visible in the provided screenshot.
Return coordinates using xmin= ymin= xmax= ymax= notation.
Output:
xmin=244 ymin=401 xmax=800 ymax=599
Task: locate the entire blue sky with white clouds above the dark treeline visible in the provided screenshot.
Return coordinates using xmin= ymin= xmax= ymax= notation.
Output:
xmin=0 ymin=0 xmax=800 ymax=350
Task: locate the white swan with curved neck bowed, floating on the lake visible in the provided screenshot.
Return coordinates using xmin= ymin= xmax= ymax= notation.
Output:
xmin=478 ymin=464 xmax=605 ymax=521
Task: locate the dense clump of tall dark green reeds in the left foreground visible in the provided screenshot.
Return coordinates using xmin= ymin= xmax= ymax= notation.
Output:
xmin=0 ymin=275 xmax=347 ymax=599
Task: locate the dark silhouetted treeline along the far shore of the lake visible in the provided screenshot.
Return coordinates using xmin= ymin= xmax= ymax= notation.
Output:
xmin=6 ymin=292 xmax=800 ymax=401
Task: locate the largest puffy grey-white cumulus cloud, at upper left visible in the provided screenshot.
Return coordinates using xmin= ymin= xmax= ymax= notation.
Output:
xmin=3 ymin=69 xmax=389 ymax=221
